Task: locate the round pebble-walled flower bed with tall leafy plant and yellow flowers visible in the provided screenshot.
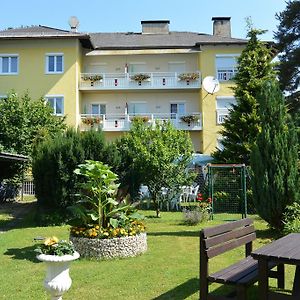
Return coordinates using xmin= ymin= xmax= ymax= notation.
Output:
xmin=70 ymin=160 xmax=147 ymax=259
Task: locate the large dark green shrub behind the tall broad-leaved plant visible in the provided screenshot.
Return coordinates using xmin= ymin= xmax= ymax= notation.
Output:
xmin=32 ymin=129 xmax=118 ymax=219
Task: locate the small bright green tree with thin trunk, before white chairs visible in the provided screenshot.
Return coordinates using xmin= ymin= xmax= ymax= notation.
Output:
xmin=117 ymin=121 xmax=192 ymax=216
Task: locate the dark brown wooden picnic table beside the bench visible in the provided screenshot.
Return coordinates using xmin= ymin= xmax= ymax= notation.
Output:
xmin=251 ymin=233 xmax=300 ymax=300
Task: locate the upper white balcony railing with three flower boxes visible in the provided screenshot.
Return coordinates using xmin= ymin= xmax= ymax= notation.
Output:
xmin=79 ymin=71 xmax=201 ymax=90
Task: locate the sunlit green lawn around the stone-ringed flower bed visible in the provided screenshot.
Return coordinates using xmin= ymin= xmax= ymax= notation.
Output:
xmin=0 ymin=206 xmax=293 ymax=300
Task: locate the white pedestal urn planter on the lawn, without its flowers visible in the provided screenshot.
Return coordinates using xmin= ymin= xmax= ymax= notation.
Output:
xmin=37 ymin=252 xmax=80 ymax=300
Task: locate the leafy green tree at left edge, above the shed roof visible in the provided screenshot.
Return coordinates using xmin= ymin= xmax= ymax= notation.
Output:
xmin=0 ymin=92 xmax=65 ymax=178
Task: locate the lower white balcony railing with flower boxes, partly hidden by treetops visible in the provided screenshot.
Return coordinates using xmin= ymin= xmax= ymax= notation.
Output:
xmin=80 ymin=112 xmax=202 ymax=131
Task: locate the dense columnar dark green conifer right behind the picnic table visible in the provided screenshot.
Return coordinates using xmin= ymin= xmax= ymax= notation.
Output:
xmin=251 ymin=81 xmax=299 ymax=228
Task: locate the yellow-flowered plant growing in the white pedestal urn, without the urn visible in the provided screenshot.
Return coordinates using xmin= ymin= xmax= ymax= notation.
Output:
xmin=34 ymin=236 xmax=75 ymax=256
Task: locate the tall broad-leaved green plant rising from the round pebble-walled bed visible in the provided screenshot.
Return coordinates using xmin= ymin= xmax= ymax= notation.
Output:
xmin=70 ymin=160 xmax=141 ymax=232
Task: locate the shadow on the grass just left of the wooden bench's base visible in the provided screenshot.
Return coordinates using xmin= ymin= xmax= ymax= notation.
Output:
xmin=152 ymin=278 xmax=199 ymax=300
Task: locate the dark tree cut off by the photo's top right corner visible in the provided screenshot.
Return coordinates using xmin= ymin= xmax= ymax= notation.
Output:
xmin=275 ymin=0 xmax=300 ymax=119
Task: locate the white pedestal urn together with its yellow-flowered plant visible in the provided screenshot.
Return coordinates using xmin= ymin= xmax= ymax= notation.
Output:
xmin=35 ymin=237 xmax=80 ymax=300
